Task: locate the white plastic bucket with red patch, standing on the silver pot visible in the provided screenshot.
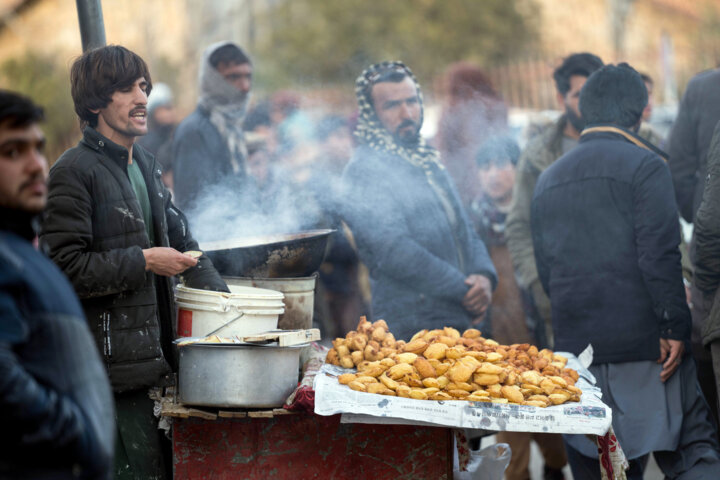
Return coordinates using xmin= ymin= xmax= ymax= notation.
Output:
xmin=175 ymin=287 xmax=285 ymax=337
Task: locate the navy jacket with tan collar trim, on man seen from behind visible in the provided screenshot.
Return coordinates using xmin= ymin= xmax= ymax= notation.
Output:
xmin=531 ymin=127 xmax=690 ymax=363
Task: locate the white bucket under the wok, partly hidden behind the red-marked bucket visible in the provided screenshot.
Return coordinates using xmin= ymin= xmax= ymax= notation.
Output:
xmin=223 ymin=274 xmax=317 ymax=330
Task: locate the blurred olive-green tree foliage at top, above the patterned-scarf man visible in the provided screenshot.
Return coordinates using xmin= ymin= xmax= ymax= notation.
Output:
xmin=256 ymin=0 xmax=538 ymax=87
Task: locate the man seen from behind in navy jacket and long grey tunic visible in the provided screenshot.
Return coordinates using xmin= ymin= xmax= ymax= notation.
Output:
xmin=531 ymin=64 xmax=720 ymax=479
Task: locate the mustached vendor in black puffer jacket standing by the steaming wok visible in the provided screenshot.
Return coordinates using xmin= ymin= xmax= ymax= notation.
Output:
xmin=40 ymin=46 xmax=228 ymax=479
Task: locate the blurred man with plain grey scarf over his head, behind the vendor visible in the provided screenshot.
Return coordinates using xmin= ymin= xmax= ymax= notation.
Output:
xmin=172 ymin=42 xmax=253 ymax=212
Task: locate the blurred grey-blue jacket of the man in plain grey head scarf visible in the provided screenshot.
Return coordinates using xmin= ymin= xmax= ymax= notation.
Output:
xmin=172 ymin=107 xmax=247 ymax=212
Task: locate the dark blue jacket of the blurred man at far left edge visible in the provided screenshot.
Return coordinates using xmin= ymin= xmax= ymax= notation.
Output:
xmin=0 ymin=209 xmax=115 ymax=479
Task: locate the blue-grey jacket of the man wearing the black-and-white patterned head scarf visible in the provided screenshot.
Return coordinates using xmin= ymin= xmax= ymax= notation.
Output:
xmin=342 ymin=146 xmax=497 ymax=340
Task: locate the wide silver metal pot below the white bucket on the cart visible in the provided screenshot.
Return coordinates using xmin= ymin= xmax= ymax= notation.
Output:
xmin=178 ymin=343 xmax=307 ymax=408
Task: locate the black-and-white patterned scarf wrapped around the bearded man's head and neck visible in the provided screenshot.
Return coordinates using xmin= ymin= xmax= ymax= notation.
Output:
xmin=355 ymin=62 xmax=442 ymax=168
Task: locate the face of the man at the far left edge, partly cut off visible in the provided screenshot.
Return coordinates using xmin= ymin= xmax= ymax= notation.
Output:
xmin=0 ymin=123 xmax=48 ymax=214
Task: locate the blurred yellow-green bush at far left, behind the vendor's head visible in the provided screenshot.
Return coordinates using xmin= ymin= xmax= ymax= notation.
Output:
xmin=0 ymin=52 xmax=80 ymax=165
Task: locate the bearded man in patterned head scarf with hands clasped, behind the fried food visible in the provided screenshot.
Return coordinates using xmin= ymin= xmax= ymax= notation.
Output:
xmin=341 ymin=62 xmax=497 ymax=340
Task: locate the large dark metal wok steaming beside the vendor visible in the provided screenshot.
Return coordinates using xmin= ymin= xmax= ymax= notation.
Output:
xmin=200 ymin=229 xmax=335 ymax=278
